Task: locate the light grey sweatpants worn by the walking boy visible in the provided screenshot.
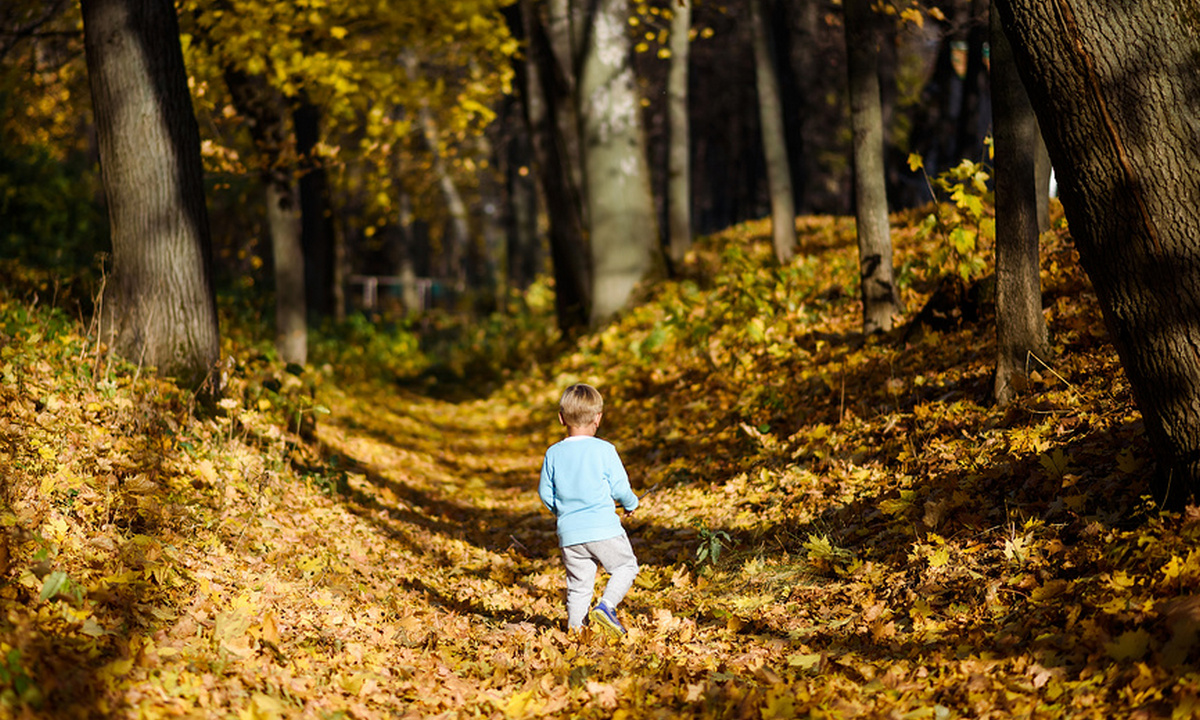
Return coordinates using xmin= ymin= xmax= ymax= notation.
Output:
xmin=563 ymin=533 xmax=637 ymax=630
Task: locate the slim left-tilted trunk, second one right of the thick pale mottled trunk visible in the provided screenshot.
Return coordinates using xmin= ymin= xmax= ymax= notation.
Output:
xmin=750 ymin=0 xmax=796 ymax=264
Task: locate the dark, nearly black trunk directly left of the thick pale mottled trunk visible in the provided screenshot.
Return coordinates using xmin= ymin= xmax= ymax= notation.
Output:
xmin=521 ymin=0 xmax=592 ymax=332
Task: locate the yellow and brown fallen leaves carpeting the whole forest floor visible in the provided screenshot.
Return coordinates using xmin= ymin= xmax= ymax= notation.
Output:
xmin=0 ymin=205 xmax=1200 ymax=720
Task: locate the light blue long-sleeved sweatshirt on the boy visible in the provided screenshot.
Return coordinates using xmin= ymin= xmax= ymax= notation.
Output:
xmin=538 ymin=436 xmax=637 ymax=547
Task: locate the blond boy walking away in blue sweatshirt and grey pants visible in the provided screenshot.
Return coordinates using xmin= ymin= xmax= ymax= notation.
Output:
xmin=538 ymin=384 xmax=637 ymax=635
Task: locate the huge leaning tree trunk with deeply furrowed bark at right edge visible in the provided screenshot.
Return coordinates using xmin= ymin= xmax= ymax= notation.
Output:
xmin=996 ymin=0 xmax=1200 ymax=504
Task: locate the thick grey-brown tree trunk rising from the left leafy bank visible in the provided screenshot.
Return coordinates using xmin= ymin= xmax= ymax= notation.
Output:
xmin=83 ymin=0 xmax=220 ymax=394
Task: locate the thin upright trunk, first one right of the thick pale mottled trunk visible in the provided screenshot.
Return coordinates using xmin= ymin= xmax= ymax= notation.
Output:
xmin=667 ymin=2 xmax=691 ymax=268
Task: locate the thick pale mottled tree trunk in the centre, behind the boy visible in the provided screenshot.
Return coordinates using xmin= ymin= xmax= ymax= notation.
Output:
xmin=577 ymin=0 xmax=661 ymax=325
